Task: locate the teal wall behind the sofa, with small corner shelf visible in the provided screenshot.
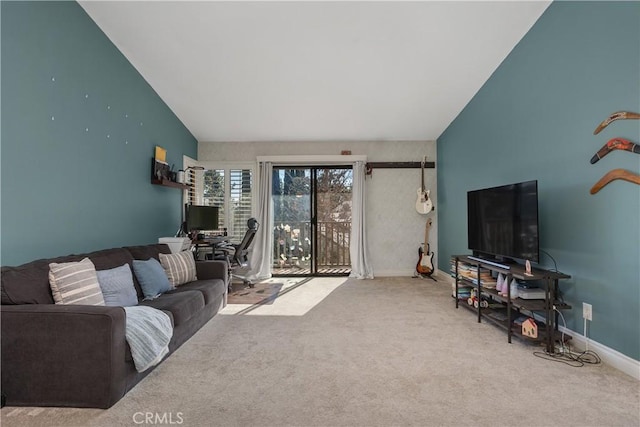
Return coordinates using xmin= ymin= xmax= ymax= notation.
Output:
xmin=0 ymin=1 xmax=197 ymax=265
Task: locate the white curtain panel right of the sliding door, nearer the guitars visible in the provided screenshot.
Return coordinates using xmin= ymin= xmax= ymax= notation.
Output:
xmin=349 ymin=161 xmax=373 ymax=279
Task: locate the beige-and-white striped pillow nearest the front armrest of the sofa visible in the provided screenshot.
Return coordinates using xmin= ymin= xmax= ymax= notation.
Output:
xmin=49 ymin=258 xmax=104 ymax=305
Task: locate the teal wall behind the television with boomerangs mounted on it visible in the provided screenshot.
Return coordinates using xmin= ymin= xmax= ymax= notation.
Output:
xmin=437 ymin=2 xmax=640 ymax=360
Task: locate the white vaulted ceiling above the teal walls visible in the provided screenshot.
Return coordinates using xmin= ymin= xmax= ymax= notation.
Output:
xmin=80 ymin=1 xmax=550 ymax=141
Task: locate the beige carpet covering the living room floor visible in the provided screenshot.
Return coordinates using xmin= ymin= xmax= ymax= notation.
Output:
xmin=2 ymin=278 xmax=640 ymax=427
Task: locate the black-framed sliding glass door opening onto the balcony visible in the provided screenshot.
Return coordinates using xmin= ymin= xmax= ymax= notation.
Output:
xmin=272 ymin=166 xmax=353 ymax=276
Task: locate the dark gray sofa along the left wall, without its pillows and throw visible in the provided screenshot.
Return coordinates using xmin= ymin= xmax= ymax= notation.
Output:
xmin=0 ymin=244 xmax=229 ymax=408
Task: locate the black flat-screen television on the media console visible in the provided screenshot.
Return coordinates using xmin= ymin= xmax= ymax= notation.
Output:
xmin=467 ymin=180 xmax=540 ymax=263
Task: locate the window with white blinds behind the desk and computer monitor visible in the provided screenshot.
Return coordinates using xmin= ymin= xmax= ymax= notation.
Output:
xmin=187 ymin=168 xmax=253 ymax=241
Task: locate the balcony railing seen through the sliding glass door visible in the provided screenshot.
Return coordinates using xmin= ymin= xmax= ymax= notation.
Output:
xmin=273 ymin=221 xmax=351 ymax=270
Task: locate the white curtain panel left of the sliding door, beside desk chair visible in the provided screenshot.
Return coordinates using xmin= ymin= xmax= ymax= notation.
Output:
xmin=246 ymin=162 xmax=273 ymax=280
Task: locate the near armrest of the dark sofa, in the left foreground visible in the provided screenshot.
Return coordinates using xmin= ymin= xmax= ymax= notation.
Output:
xmin=0 ymin=304 xmax=127 ymax=408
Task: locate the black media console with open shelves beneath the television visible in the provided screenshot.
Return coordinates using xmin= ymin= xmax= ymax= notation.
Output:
xmin=451 ymin=255 xmax=571 ymax=353
